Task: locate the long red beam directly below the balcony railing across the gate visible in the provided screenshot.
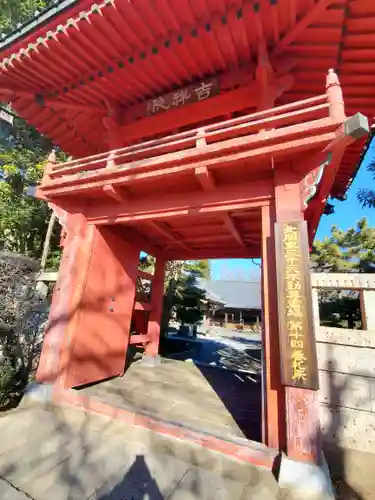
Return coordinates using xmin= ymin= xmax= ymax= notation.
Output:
xmin=40 ymin=118 xmax=337 ymax=196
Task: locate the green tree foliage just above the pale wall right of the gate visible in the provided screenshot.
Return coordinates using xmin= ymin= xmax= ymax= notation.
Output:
xmin=311 ymin=218 xmax=375 ymax=273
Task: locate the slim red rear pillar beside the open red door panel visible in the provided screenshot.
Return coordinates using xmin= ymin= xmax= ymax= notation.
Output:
xmin=145 ymin=257 xmax=165 ymax=356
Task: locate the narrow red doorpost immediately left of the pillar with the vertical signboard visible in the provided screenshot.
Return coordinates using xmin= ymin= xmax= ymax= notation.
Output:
xmin=262 ymin=205 xmax=286 ymax=450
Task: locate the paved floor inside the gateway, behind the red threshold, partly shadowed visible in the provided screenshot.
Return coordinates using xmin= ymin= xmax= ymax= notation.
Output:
xmin=78 ymin=359 xmax=261 ymax=442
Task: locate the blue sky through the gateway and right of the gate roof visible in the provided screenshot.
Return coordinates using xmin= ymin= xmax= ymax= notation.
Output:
xmin=211 ymin=140 xmax=375 ymax=280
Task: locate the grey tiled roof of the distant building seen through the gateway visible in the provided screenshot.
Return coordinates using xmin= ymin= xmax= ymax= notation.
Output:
xmin=200 ymin=280 xmax=261 ymax=309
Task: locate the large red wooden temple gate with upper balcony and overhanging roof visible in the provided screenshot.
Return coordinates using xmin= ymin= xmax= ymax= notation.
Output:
xmin=0 ymin=0 xmax=375 ymax=476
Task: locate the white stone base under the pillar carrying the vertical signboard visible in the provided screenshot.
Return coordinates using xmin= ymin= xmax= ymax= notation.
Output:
xmin=279 ymin=454 xmax=335 ymax=500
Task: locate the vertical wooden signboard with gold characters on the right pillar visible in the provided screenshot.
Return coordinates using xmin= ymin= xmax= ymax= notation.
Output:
xmin=275 ymin=221 xmax=319 ymax=390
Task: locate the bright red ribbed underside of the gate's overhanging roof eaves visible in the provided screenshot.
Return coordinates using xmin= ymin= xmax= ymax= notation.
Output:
xmin=0 ymin=0 xmax=375 ymax=197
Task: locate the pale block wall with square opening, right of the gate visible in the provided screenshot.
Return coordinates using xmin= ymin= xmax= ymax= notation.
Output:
xmin=312 ymin=274 xmax=375 ymax=453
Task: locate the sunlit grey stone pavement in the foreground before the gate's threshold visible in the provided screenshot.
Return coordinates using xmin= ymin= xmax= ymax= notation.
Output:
xmin=0 ymin=404 xmax=279 ymax=500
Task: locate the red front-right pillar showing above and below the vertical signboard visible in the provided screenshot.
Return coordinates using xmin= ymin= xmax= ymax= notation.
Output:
xmin=275 ymin=169 xmax=321 ymax=463
